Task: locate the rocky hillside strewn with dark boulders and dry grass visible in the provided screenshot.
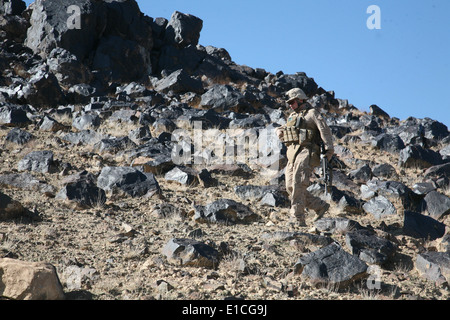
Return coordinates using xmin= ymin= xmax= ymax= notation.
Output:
xmin=0 ymin=0 xmax=450 ymax=300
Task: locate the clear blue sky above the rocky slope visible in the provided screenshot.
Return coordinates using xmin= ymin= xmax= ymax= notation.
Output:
xmin=22 ymin=0 xmax=450 ymax=128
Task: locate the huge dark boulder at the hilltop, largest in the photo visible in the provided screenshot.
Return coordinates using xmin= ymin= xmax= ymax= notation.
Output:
xmin=25 ymin=0 xmax=153 ymax=81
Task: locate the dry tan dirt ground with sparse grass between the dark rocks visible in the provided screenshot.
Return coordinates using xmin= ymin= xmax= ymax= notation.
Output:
xmin=0 ymin=117 xmax=450 ymax=300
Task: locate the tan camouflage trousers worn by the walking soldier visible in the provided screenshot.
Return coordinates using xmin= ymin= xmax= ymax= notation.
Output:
xmin=285 ymin=148 xmax=328 ymax=220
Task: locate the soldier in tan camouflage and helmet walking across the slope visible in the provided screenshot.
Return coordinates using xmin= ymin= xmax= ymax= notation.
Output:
xmin=276 ymin=88 xmax=334 ymax=226
